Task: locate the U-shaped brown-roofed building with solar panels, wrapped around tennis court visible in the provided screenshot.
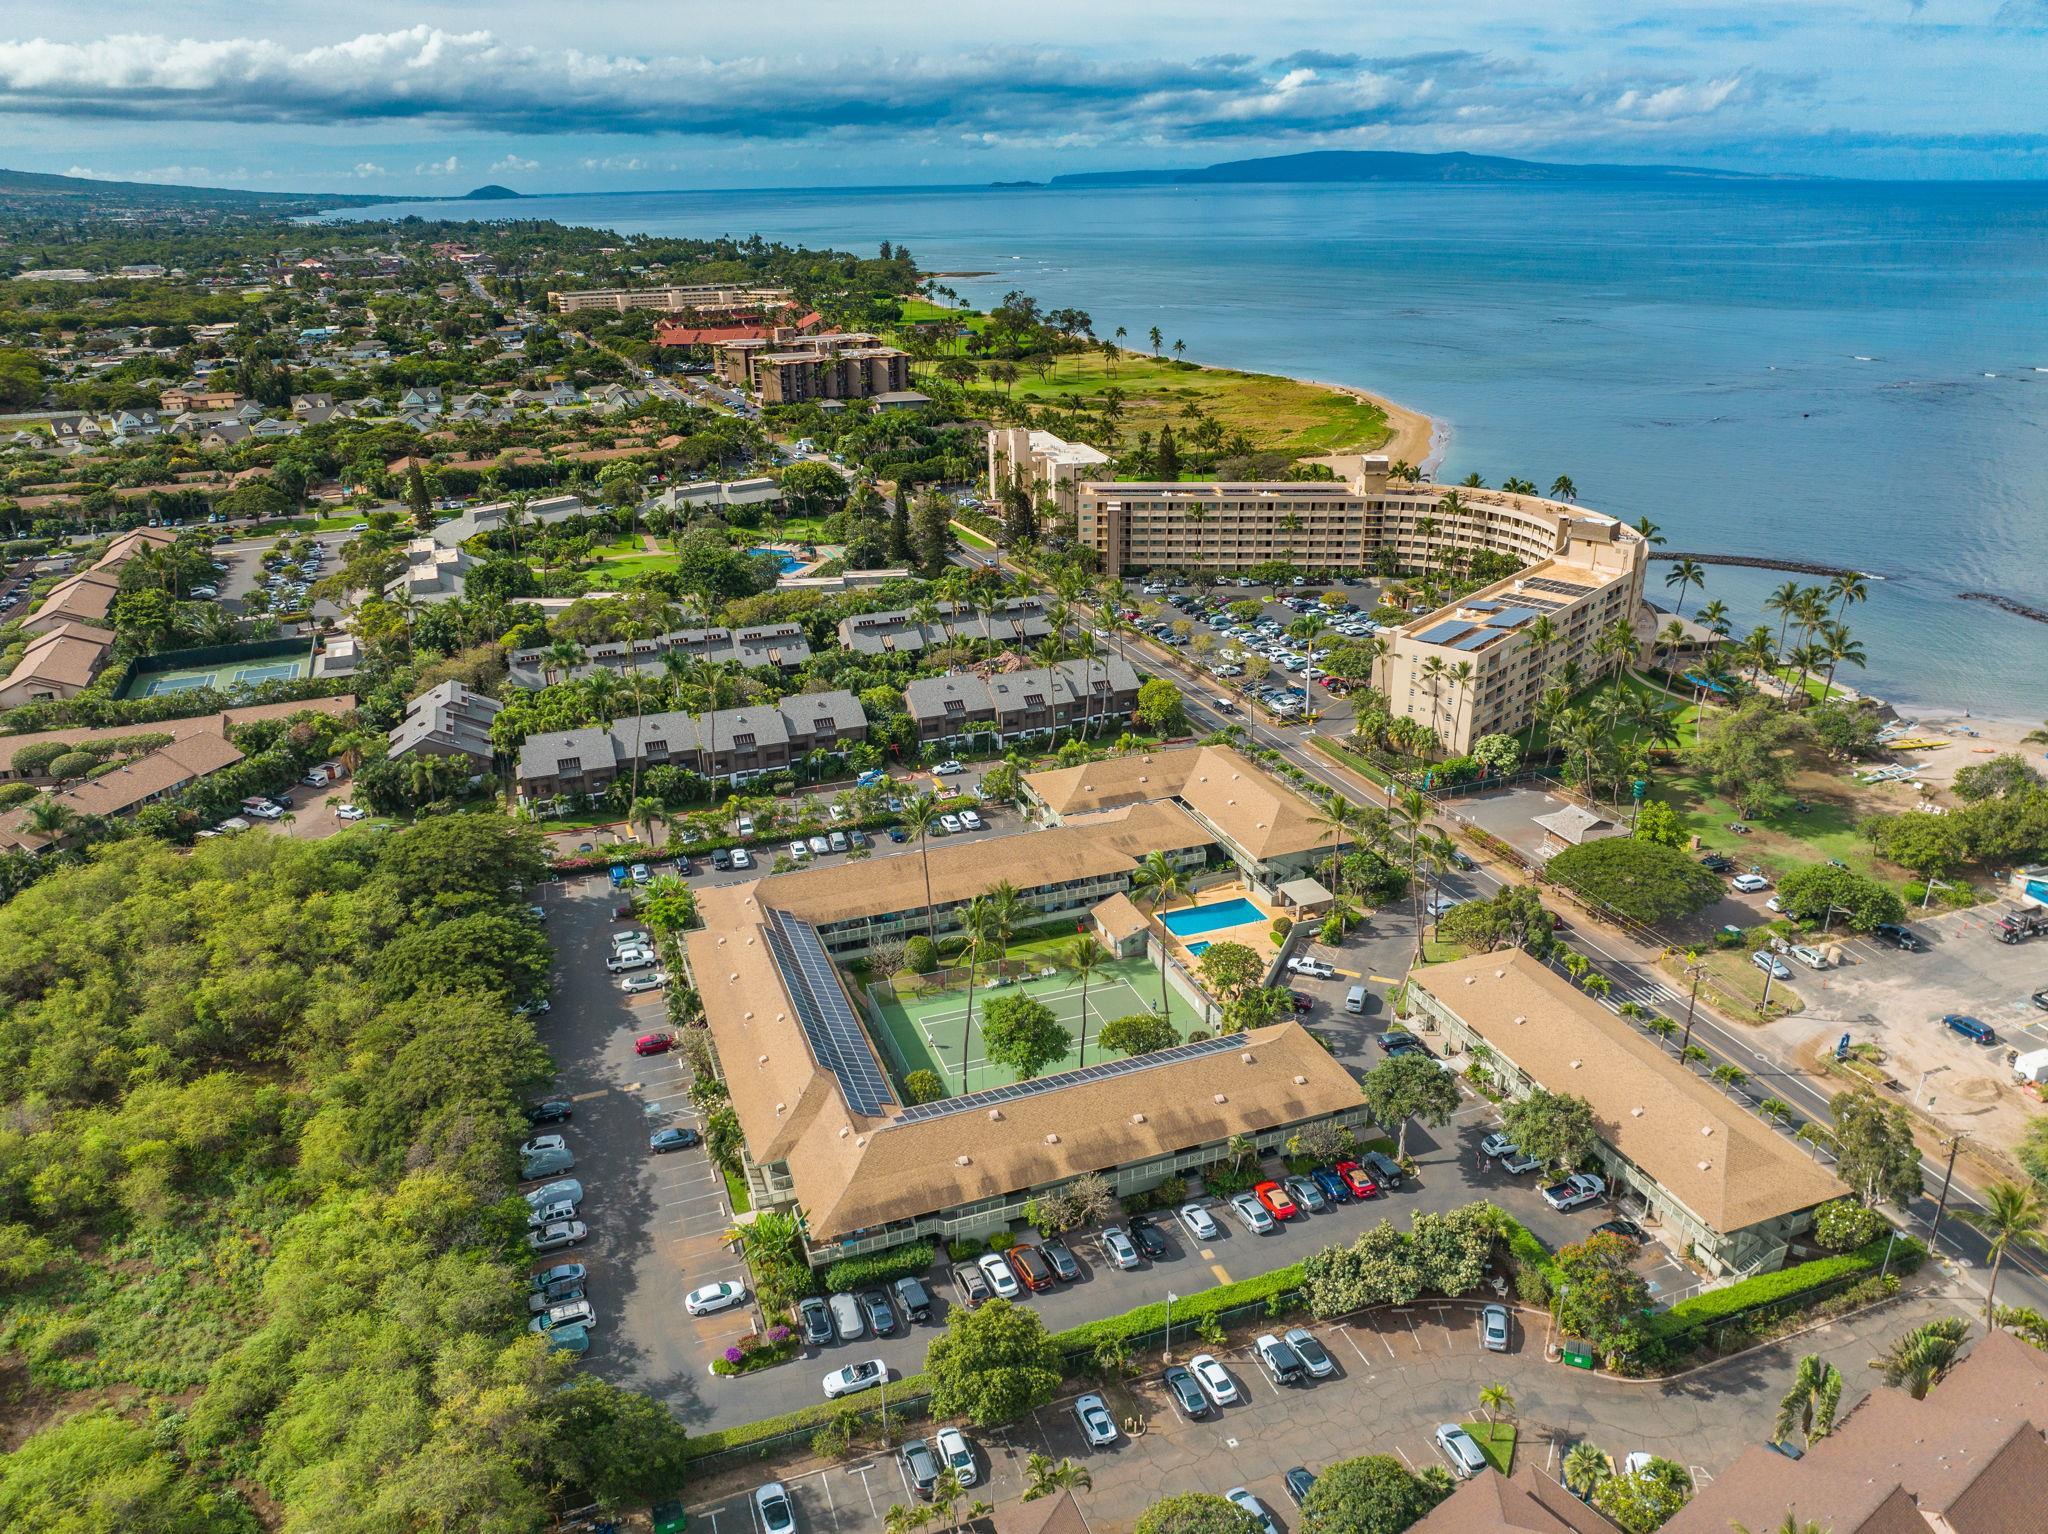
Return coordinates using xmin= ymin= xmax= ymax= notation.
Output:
xmin=684 ymin=745 xmax=1370 ymax=1262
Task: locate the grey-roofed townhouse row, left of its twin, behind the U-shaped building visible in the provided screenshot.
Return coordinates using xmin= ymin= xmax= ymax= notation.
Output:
xmin=516 ymin=692 xmax=868 ymax=803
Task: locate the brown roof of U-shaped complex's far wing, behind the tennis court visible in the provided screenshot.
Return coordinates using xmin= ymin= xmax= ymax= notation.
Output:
xmin=770 ymin=805 xmax=1212 ymax=926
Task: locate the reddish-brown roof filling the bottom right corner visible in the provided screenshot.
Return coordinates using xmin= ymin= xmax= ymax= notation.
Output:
xmin=1665 ymin=1331 xmax=2048 ymax=1534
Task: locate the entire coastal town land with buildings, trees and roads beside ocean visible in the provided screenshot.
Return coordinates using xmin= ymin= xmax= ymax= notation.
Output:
xmin=0 ymin=197 xmax=2048 ymax=1534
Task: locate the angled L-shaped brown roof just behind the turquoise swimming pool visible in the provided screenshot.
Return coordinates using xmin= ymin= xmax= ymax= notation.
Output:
xmin=1024 ymin=745 xmax=1329 ymax=860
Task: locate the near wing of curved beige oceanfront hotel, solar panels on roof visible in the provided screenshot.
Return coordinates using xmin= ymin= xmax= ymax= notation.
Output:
xmin=1372 ymin=518 xmax=1645 ymax=754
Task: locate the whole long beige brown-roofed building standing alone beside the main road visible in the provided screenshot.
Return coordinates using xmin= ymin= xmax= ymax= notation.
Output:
xmin=1407 ymin=948 xmax=1849 ymax=1274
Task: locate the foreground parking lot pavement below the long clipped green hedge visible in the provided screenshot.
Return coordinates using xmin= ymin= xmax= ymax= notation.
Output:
xmin=688 ymin=1296 xmax=1954 ymax=1534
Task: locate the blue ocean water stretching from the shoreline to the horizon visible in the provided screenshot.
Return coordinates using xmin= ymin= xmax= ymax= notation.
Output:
xmin=339 ymin=182 xmax=2048 ymax=719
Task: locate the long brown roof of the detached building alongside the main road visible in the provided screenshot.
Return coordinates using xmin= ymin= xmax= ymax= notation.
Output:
xmin=1409 ymin=950 xmax=1847 ymax=1233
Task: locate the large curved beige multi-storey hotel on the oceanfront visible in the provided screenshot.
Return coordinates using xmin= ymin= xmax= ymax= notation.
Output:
xmin=989 ymin=430 xmax=1649 ymax=754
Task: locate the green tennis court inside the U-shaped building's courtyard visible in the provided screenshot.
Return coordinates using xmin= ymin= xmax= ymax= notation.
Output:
xmin=868 ymin=958 xmax=1204 ymax=1096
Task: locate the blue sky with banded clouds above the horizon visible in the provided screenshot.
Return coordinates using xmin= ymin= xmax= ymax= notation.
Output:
xmin=0 ymin=0 xmax=2048 ymax=197
